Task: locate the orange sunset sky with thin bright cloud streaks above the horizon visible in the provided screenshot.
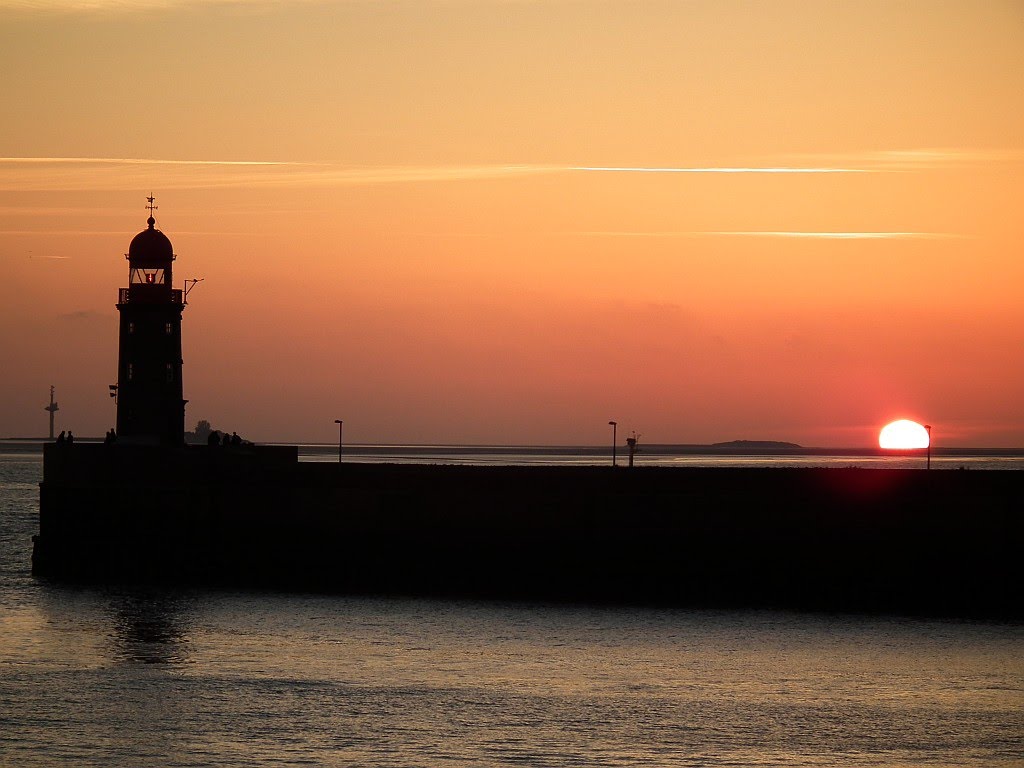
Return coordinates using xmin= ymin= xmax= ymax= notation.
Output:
xmin=0 ymin=0 xmax=1024 ymax=446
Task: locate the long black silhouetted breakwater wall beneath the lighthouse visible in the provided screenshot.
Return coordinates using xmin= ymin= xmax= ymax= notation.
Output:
xmin=33 ymin=443 xmax=1024 ymax=621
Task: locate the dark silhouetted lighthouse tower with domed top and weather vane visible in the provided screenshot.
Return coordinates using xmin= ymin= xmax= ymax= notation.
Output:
xmin=117 ymin=197 xmax=186 ymax=446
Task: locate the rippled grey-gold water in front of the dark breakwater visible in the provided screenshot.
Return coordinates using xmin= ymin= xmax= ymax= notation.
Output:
xmin=0 ymin=454 xmax=1024 ymax=767
